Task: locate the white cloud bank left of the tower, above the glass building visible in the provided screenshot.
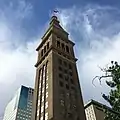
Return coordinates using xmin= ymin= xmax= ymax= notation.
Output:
xmin=0 ymin=0 xmax=40 ymax=120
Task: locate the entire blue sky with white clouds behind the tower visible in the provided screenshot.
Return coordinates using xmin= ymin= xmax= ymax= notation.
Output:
xmin=0 ymin=0 xmax=120 ymax=120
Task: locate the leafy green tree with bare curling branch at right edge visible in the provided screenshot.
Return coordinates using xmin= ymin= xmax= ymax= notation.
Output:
xmin=93 ymin=61 xmax=120 ymax=120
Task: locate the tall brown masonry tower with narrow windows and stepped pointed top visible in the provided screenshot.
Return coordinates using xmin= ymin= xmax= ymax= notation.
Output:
xmin=32 ymin=16 xmax=86 ymax=120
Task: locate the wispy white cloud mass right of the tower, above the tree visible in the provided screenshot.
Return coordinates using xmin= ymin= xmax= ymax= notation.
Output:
xmin=59 ymin=5 xmax=120 ymax=102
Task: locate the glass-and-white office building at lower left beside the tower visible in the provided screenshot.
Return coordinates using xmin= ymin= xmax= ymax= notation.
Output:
xmin=3 ymin=86 xmax=33 ymax=120
